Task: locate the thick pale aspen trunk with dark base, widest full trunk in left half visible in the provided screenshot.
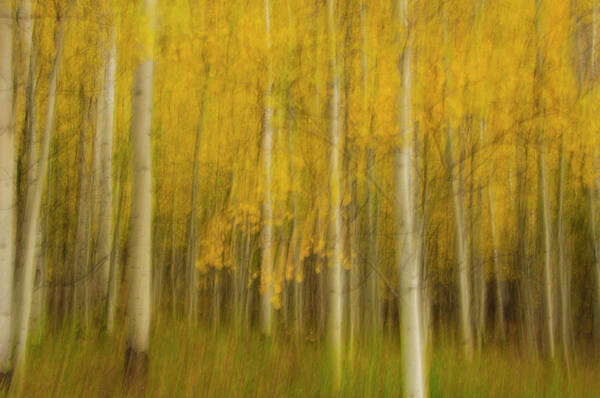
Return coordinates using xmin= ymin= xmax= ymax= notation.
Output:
xmin=127 ymin=0 xmax=156 ymax=353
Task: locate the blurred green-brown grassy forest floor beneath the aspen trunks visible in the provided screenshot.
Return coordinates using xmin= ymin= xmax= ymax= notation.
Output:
xmin=5 ymin=320 xmax=600 ymax=398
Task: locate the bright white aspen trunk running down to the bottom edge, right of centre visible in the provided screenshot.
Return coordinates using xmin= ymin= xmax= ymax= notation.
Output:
xmin=394 ymin=0 xmax=425 ymax=398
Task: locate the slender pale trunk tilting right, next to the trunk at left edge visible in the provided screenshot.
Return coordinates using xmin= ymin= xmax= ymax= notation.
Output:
xmin=15 ymin=16 xmax=66 ymax=379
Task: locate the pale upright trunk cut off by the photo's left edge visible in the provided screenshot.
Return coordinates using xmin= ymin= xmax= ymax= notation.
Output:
xmin=0 ymin=0 xmax=17 ymax=373
